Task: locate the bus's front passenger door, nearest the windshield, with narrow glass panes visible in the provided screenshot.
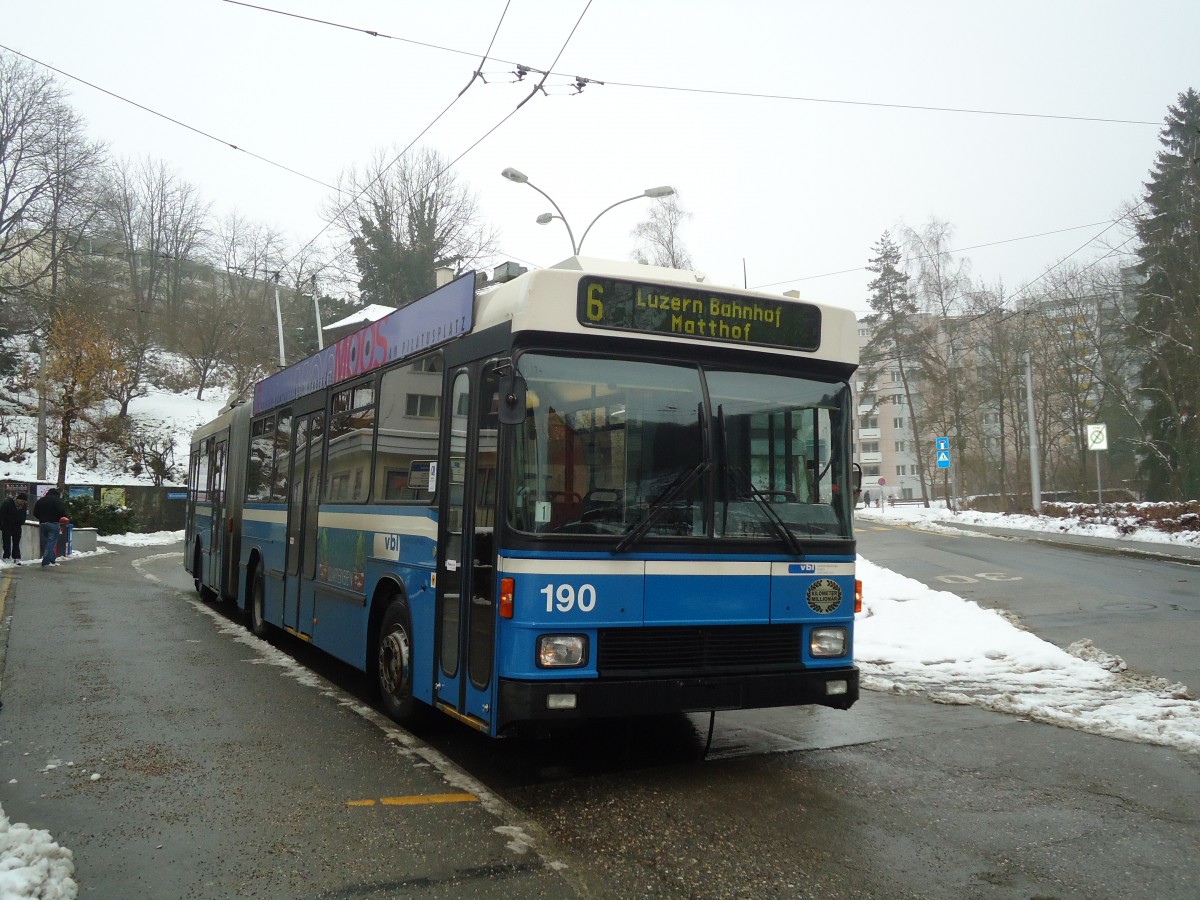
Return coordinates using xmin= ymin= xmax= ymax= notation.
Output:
xmin=434 ymin=370 xmax=498 ymax=731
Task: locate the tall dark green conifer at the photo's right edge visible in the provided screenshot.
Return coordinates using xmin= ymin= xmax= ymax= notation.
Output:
xmin=1134 ymin=89 xmax=1200 ymax=499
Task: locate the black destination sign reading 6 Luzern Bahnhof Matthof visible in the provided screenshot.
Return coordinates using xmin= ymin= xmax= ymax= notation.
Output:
xmin=576 ymin=276 xmax=821 ymax=352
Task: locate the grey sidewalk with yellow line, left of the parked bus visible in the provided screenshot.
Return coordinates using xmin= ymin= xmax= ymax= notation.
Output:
xmin=0 ymin=550 xmax=576 ymax=899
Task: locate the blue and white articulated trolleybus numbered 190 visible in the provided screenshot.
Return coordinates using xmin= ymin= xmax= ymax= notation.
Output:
xmin=185 ymin=257 xmax=860 ymax=736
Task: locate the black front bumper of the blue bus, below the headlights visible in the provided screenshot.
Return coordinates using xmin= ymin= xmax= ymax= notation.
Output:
xmin=497 ymin=666 xmax=858 ymax=730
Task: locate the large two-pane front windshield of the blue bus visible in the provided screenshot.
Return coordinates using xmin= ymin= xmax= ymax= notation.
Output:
xmin=505 ymin=353 xmax=851 ymax=552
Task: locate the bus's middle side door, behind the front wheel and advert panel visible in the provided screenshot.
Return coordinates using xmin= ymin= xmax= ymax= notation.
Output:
xmin=283 ymin=413 xmax=324 ymax=635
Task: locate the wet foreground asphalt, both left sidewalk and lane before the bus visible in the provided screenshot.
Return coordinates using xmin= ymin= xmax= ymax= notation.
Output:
xmin=0 ymin=540 xmax=1200 ymax=900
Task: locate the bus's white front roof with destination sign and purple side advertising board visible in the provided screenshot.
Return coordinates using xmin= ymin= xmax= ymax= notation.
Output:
xmin=253 ymin=256 xmax=858 ymax=415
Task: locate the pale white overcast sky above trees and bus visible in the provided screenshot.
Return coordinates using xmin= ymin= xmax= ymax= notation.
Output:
xmin=0 ymin=0 xmax=1200 ymax=310
